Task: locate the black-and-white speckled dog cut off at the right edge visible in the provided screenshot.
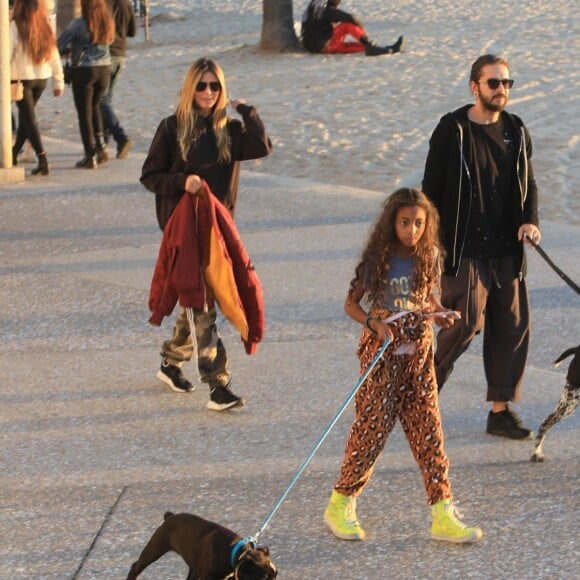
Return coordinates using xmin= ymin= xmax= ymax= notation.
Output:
xmin=530 ymin=345 xmax=580 ymax=462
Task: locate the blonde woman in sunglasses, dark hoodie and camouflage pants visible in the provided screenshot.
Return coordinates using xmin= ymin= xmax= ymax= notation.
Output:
xmin=141 ymin=58 xmax=272 ymax=411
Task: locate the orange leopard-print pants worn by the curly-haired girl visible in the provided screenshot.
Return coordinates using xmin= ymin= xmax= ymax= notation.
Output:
xmin=334 ymin=309 xmax=451 ymax=505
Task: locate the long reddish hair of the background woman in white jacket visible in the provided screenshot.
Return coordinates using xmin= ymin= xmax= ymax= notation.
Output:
xmin=12 ymin=0 xmax=56 ymax=64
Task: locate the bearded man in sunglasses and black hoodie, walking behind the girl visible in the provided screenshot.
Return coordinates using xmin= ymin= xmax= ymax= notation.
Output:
xmin=423 ymin=54 xmax=541 ymax=439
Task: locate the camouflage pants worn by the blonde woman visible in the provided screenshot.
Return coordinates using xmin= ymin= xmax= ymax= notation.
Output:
xmin=161 ymin=308 xmax=231 ymax=387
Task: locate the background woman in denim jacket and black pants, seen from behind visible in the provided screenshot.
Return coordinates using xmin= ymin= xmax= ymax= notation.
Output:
xmin=58 ymin=0 xmax=115 ymax=169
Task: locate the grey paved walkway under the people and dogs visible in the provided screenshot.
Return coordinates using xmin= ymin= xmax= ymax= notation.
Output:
xmin=0 ymin=139 xmax=580 ymax=580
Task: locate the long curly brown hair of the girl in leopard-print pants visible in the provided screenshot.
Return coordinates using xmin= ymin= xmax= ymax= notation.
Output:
xmin=349 ymin=188 xmax=444 ymax=307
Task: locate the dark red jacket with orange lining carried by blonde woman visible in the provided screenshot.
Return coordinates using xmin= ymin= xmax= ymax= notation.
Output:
xmin=149 ymin=182 xmax=265 ymax=354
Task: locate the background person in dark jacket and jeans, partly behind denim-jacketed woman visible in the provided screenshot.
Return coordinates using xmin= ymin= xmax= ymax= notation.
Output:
xmin=101 ymin=0 xmax=137 ymax=159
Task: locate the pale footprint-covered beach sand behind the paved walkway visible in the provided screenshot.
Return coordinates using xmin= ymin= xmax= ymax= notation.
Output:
xmin=32 ymin=0 xmax=580 ymax=224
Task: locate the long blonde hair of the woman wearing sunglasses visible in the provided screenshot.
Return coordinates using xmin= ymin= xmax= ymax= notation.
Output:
xmin=176 ymin=58 xmax=231 ymax=163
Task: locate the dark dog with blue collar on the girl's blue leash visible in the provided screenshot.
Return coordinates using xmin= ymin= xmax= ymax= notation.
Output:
xmin=127 ymin=512 xmax=278 ymax=580
